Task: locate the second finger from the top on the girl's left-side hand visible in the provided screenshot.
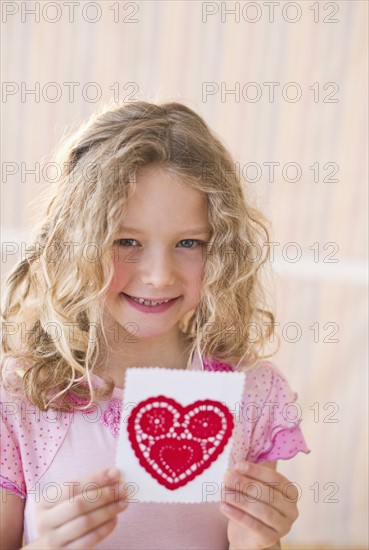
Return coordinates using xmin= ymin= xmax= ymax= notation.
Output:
xmin=37 ymin=482 xmax=127 ymax=534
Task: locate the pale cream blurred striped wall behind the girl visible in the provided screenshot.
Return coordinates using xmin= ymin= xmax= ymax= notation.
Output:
xmin=1 ymin=0 xmax=368 ymax=549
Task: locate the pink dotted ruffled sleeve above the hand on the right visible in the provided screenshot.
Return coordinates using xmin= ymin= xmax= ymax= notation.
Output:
xmin=232 ymin=361 xmax=311 ymax=463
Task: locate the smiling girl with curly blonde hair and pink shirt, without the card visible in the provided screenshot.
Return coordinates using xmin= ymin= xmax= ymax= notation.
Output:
xmin=1 ymin=101 xmax=310 ymax=550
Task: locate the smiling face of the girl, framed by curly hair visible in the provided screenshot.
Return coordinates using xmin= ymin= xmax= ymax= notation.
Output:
xmin=102 ymin=166 xmax=210 ymax=342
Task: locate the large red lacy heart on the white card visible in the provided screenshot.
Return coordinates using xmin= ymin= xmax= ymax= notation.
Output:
xmin=127 ymin=395 xmax=234 ymax=490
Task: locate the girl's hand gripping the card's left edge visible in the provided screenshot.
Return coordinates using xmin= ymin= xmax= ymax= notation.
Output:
xmin=24 ymin=468 xmax=128 ymax=550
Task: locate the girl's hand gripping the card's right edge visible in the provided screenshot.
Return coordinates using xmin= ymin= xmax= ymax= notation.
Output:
xmin=220 ymin=461 xmax=299 ymax=550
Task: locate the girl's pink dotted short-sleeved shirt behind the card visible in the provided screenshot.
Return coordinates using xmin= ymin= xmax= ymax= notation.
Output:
xmin=0 ymin=361 xmax=310 ymax=550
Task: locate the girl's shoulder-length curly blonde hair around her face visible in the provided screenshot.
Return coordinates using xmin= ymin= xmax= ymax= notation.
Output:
xmin=1 ymin=101 xmax=279 ymax=411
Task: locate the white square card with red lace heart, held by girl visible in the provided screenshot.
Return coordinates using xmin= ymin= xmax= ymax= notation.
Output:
xmin=116 ymin=367 xmax=245 ymax=502
